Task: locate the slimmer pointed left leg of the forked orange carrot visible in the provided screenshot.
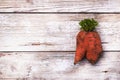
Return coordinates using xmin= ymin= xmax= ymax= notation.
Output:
xmin=74 ymin=31 xmax=86 ymax=65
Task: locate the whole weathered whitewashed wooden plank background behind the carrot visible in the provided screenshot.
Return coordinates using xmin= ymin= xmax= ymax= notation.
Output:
xmin=0 ymin=0 xmax=120 ymax=80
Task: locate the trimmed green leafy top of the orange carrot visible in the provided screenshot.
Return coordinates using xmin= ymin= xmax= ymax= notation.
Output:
xmin=79 ymin=18 xmax=98 ymax=32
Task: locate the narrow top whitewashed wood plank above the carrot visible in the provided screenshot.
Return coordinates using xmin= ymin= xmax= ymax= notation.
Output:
xmin=0 ymin=0 xmax=120 ymax=12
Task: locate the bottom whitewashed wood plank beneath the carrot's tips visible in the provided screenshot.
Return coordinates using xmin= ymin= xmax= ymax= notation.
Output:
xmin=0 ymin=52 xmax=120 ymax=80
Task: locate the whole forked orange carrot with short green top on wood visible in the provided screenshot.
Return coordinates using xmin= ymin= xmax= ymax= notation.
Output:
xmin=74 ymin=19 xmax=102 ymax=64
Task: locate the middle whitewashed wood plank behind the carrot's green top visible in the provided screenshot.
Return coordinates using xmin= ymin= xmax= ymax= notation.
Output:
xmin=0 ymin=14 xmax=120 ymax=51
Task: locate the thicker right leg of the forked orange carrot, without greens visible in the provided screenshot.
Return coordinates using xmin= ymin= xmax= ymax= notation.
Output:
xmin=85 ymin=32 xmax=102 ymax=64
